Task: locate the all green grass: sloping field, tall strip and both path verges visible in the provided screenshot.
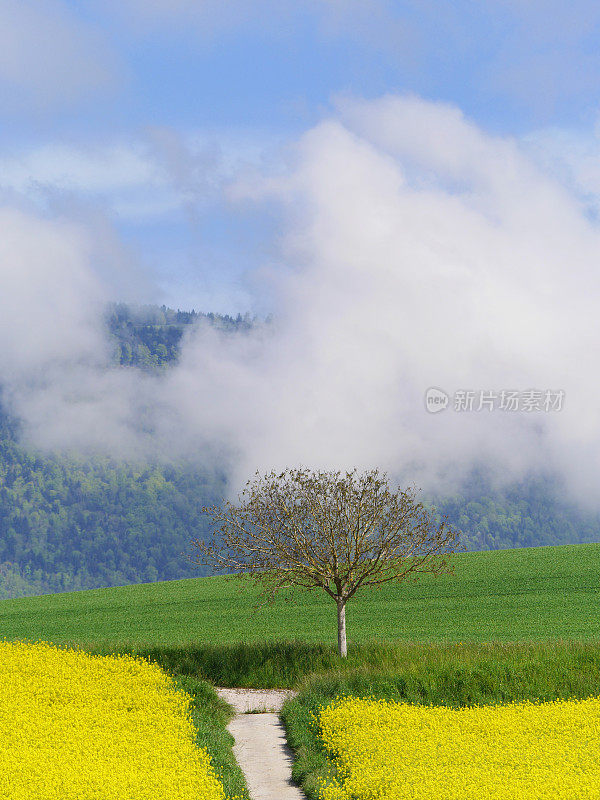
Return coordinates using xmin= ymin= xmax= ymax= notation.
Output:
xmin=0 ymin=544 xmax=600 ymax=798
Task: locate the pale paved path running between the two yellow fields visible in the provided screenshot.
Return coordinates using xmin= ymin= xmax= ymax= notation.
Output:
xmin=217 ymin=688 xmax=305 ymax=800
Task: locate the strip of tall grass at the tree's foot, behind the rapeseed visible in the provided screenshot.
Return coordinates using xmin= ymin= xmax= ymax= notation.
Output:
xmin=31 ymin=638 xmax=600 ymax=692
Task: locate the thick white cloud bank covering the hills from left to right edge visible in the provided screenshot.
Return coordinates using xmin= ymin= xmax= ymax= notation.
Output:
xmin=0 ymin=96 xmax=600 ymax=506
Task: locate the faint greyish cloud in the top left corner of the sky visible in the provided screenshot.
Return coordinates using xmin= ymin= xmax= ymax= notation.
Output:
xmin=0 ymin=0 xmax=122 ymax=110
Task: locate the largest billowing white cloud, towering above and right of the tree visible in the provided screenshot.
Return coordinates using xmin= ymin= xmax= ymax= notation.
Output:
xmin=165 ymin=97 xmax=600 ymax=502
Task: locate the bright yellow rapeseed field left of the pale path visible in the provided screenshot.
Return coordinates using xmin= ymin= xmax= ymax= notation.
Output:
xmin=0 ymin=641 xmax=236 ymax=800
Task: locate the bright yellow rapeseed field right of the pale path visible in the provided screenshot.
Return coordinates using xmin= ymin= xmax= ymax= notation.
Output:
xmin=320 ymin=698 xmax=600 ymax=800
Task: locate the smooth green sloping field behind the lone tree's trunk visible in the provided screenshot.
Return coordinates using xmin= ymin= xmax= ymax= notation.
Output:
xmin=0 ymin=544 xmax=600 ymax=647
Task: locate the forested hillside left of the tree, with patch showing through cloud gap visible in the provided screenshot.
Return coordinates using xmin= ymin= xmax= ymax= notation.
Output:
xmin=0 ymin=304 xmax=245 ymax=599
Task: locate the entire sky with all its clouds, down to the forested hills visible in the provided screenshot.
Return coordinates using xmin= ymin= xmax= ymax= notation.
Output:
xmin=0 ymin=0 xmax=600 ymax=506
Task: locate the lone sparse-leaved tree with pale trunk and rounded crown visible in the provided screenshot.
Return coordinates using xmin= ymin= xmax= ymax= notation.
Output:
xmin=189 ymin=469 xmax=462 ymax=656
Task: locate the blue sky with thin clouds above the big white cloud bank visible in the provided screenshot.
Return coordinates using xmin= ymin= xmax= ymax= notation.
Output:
xmin=0 ymin=0 xmax=600 ymax=313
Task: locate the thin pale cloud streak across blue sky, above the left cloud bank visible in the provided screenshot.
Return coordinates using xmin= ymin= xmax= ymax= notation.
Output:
xmin=0 ymin=127 xmax=277 ymax=222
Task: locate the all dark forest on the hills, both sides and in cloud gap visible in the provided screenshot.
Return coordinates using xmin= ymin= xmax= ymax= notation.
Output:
xmin=0 ymin=304 xmax=600 ymax=598
